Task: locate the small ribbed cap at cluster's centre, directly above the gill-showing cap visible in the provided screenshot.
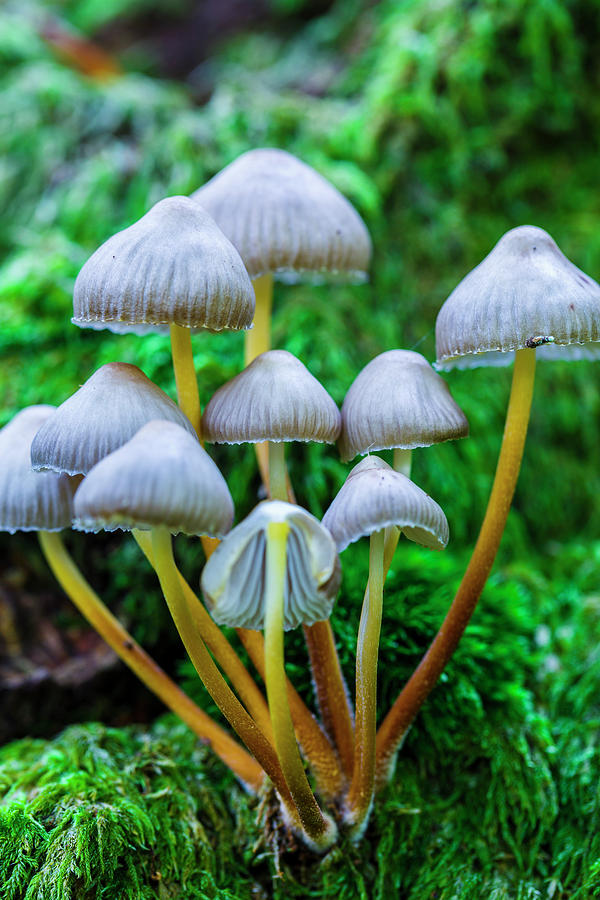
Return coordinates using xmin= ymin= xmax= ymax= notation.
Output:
xmin=202 ymin=350 xmax=341 ymax=444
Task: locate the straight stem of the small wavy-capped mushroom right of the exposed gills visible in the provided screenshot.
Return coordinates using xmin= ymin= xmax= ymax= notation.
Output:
xmin=344 ymin=528 xmax=385 ymax=840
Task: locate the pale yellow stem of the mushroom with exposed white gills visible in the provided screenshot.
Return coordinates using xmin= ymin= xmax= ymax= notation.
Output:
xmin=265 ymin=522 xmax=336 ymax=850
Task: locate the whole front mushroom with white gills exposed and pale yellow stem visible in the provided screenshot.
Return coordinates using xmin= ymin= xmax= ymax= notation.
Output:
xmin=202 ymin=500 xmax=339 ymax=850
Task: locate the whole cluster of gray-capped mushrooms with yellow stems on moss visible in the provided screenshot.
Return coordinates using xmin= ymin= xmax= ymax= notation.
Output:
xmin=5 ymin=149 xmax=600 ymax=852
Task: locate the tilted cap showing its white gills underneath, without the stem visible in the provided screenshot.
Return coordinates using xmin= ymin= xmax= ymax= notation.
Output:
xmin=202 ymin=500 xmax=340 ymax=631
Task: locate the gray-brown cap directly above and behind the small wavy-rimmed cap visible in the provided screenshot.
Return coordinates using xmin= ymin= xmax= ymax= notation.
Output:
xmin=339 ymin=350 xmax=469 ymax=462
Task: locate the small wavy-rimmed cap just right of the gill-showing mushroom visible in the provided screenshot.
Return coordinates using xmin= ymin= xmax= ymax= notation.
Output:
xmin=322 ymin=456 xmax=448 ymax=553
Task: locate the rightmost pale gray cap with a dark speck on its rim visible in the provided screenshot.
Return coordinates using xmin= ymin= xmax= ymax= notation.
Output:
xmin=436 ymin=225 xmax=600 ymax=370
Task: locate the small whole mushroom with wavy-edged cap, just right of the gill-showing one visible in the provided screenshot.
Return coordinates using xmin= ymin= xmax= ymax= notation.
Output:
xmin=322 ymin=456 xmax=448 ymax=839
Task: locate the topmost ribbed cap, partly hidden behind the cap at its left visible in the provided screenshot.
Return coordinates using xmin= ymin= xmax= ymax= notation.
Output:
xmin=192 ymin=149 xmax=371 ymax=281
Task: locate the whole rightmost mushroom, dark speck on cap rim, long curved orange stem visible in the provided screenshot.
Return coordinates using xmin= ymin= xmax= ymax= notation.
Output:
xmin=377 ymin=225 xmax=600 ymax=782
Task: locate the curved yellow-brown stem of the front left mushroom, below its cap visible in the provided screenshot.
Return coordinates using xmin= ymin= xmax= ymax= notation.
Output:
xmin=152 ymin=526 xmax=300 ymax=827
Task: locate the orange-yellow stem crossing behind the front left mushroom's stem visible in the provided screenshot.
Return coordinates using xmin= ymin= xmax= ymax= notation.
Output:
xmin=132 ymin=529 xmax=273 ymax=743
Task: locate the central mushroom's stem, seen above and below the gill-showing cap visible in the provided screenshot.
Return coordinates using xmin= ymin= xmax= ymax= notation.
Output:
xmin=268 ymin=441 xmax=354 ymax=779
